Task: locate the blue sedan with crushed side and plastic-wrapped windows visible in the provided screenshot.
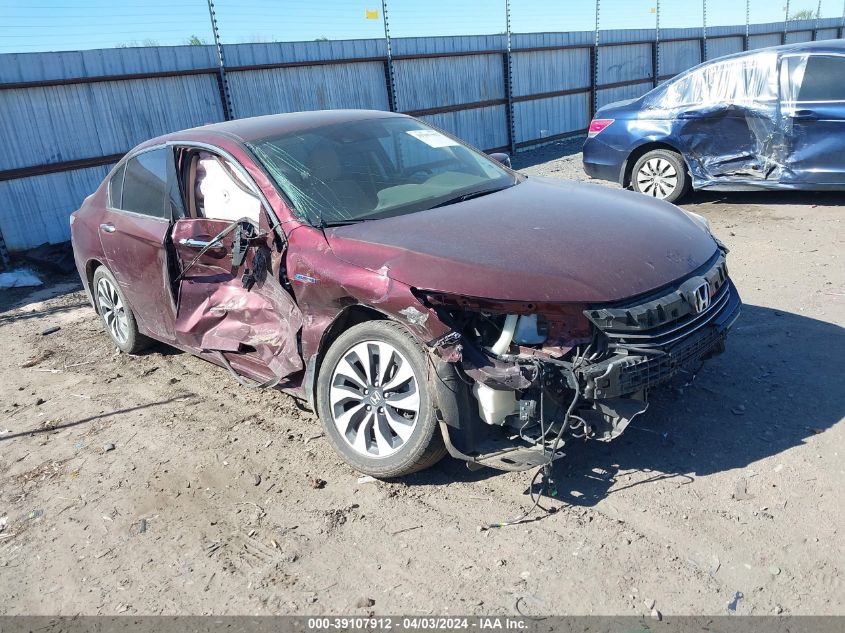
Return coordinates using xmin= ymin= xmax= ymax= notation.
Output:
xmin=583 ymin=40 xmax=845 ymax=202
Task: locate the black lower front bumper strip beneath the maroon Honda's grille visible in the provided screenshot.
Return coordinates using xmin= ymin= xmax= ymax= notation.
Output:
xmin=578 ymin=282 xmax=742 ymax=400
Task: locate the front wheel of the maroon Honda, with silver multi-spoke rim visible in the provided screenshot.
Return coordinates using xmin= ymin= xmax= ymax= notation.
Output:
xmin=317 ymin=321 xmax=446 ymax=478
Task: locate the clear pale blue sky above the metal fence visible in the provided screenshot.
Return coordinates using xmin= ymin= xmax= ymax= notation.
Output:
xmin=0 ymin=0 xmax=845 ymax=53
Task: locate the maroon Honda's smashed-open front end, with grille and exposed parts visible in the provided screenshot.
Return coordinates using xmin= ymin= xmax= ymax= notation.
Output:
xmin=421 ymin=250 xmax=740 ymax=470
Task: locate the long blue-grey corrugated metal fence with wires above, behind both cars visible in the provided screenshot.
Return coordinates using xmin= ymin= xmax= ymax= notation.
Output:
xmin=0 ymin=0 xmax=845 ymax=251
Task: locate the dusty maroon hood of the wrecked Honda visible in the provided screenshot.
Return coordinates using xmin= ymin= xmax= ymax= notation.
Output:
xmin=326 ymin=177 xmax=717 ymax=303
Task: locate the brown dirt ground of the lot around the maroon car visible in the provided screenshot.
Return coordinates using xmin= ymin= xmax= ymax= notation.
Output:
xmin=0 ymin=143 xmax=845 ymax=615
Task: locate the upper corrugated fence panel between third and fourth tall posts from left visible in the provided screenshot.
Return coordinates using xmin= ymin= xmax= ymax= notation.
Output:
xmin=511 ymin=48 xmax=590 ymax=96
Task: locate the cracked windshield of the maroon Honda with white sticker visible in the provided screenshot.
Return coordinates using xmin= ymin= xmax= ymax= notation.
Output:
xmin=249 ymin=117 xmax=518 ymax=226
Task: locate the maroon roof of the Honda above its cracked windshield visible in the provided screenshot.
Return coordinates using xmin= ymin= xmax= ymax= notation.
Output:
xmin=153 ymin=110 xmax=407 ymax=145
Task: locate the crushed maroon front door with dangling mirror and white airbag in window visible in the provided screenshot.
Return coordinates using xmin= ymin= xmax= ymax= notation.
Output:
xmin=166 ymin=149 xmax=303 ymax=386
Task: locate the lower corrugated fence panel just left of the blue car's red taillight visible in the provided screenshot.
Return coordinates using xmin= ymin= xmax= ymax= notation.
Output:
xmin=513 ymin=92 xmax=592 ymax=143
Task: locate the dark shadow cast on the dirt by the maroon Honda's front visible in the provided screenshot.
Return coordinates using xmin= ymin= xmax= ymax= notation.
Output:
xmin=408 ymin=305 xmax=845 ymax=506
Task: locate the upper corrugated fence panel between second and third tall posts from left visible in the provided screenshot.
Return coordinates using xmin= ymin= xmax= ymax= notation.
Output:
xmin=393 ymin=54 xmax=505 ymax=110
